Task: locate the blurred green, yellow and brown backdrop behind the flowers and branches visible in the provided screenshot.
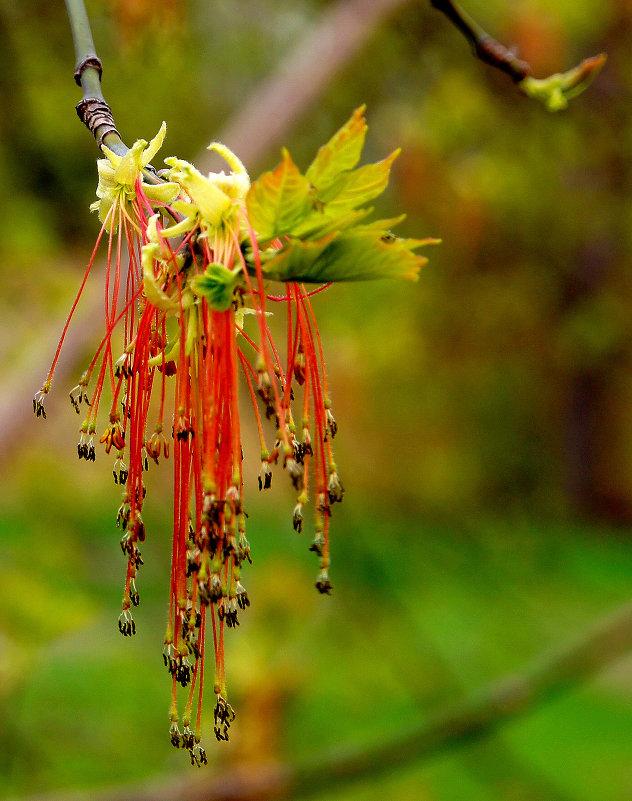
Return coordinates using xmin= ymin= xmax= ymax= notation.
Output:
xmin=0 ymin=0 xmax=632 ymax=801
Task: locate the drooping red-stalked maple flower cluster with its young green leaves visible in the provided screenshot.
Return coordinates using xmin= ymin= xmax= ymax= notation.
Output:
xmin=33 ymin=108 xmax=436 ymax=765
